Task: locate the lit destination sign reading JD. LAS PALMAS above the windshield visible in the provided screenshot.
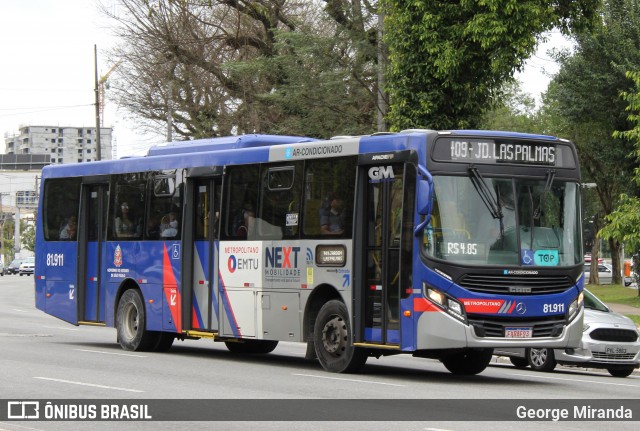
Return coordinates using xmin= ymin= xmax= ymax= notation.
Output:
xmin=433 ymin=137 xmax=576 ymax=168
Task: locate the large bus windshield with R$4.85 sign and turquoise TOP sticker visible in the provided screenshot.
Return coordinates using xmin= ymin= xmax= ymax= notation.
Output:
xmin=424 ymin=175 xmax=582 ymax=267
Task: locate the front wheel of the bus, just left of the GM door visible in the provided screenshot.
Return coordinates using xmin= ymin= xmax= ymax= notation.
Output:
xmin=313 ymin=299 xmax=369 ymax=373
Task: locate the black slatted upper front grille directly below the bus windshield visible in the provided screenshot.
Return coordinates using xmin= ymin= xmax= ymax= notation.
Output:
xmin=458 ymin=274 xmax=574 ymax=295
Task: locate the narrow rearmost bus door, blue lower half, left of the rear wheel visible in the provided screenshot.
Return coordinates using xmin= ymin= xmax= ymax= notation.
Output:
xmin=77 ymin=184 xmax=109 ymax=322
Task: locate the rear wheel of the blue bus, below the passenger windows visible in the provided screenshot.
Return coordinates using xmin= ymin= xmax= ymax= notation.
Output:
xmin=116 ymin=289 xmax=160 ymax=351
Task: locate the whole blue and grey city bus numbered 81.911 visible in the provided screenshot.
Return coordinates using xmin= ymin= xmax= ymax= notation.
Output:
xmin=35 ymin=130 xmax=584 ymax=374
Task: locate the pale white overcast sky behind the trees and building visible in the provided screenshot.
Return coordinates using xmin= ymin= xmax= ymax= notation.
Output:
xmin=0 ymin=0 xmax=566 ymax=157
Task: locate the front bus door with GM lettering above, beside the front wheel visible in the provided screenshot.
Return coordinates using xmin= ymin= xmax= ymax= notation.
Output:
xmin=357 ymin=164 xmax=404 ymax=346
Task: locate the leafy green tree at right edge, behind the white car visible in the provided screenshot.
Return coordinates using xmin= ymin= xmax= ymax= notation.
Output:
xmin=546 ymin=0 xmax=640 ymax=283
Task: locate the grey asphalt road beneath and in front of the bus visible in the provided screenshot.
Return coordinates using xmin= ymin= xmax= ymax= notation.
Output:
xmin=0 ymin=276 xmax=640 ymax=431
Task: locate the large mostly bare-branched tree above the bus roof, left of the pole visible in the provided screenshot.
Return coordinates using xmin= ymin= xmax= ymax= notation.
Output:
xmin=103 ymin=0 xmax=378 ymax=138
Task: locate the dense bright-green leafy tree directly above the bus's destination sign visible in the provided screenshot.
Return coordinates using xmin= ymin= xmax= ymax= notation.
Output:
xmin=383 ymin=0 xmax=599 ymax=130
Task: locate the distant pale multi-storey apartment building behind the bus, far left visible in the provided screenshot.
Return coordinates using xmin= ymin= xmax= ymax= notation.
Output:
xmin=5 ymin=126 xmax=112 ymax=164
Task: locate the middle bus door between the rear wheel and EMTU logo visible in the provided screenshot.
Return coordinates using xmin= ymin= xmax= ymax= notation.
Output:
xmin=183 ymin=177 xmax=222 ymax=331
